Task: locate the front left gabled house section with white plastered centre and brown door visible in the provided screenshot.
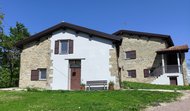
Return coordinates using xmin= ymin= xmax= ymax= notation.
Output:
xmin=17 ymin=22 xmax=121 ymax=90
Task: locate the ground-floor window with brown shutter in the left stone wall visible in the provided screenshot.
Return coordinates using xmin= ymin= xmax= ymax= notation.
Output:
xmin=31 ymin=69 xmax=47 ymax=81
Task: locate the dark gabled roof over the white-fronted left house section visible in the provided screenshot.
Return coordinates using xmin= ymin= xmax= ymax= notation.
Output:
xmin=16 ymin=22 xmax=121 ymax=48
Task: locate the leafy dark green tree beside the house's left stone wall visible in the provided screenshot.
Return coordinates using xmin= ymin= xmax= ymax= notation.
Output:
xmin=0 ymin=22 xmax=30 ymax=87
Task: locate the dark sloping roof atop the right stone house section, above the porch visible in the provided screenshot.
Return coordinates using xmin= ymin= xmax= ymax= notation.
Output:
xmin=113 ymin=30 xmax=174 ymax=46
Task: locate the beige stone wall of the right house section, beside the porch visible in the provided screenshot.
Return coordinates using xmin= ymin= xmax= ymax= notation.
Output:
xmin=119 ymin=35 xmax=167 ymax=83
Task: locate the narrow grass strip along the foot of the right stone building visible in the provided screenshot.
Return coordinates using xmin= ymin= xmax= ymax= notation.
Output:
xmin=123 ymin=81 xmax=190 ymax=90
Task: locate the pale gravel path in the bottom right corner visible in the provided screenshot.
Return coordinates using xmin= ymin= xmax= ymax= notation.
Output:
xmin=145 ymin=91 xmax=190 ymax=111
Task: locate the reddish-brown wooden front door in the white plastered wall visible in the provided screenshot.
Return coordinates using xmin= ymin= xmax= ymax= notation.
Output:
xmin=71 ymin=67 xmax=81 ymax=90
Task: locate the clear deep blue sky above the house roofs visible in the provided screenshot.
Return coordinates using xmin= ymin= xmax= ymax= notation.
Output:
xmin=0 ymin=0 xmax=190 ymax=59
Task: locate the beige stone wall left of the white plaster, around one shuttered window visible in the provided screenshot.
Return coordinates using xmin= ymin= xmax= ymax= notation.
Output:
xmin=19 ymin=37 xmax=52 ymax=89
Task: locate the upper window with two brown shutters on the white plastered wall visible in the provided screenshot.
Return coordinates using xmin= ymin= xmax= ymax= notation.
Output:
xmin=54 ymin=40 xmax=73 ymax=54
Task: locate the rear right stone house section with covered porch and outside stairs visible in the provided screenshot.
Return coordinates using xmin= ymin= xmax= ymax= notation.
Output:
xmin=114 ymin=30 xmax=189 ymax=85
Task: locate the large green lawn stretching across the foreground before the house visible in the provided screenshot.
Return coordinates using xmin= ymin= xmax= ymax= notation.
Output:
xmin=0 ymin=90 xmax=181 ymax=111
